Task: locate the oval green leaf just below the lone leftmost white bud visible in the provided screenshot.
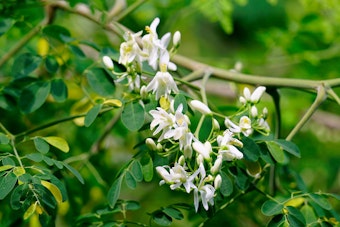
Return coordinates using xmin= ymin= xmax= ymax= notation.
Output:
xmin=86 ymin=68 xmax=115 ymax=96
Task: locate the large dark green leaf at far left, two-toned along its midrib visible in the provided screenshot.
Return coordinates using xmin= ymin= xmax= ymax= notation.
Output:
xmin=19 ymin=81 xmax=51 ymax=114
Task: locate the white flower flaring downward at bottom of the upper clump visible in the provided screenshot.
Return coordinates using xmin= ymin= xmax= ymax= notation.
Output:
xmin=146 ymin=53 xmax=178 ymax=100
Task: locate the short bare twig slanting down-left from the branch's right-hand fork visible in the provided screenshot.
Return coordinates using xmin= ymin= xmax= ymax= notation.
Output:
xmin=286 ymin=85 xmax=327 ymax=141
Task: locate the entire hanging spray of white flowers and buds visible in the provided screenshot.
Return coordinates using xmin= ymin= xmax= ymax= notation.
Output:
xmin=102 ymin=18 xmax=269 ymax=212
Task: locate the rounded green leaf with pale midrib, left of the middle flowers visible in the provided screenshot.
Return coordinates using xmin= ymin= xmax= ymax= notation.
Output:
xmin=121 ymin=102 xmax=144 ymax=131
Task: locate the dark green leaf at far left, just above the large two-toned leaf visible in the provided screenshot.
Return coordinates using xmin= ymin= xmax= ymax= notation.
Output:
xmin=12 ymin=53 xmax=42 ymax=79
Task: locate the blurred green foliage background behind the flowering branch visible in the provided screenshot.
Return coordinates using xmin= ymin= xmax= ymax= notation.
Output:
xmin=0 ymin=0 xmax=340 ymax=226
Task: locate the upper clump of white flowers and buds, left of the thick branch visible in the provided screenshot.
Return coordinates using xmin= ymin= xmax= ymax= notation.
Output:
xmin=102 ymin=18 xmax=181 ymax=96
